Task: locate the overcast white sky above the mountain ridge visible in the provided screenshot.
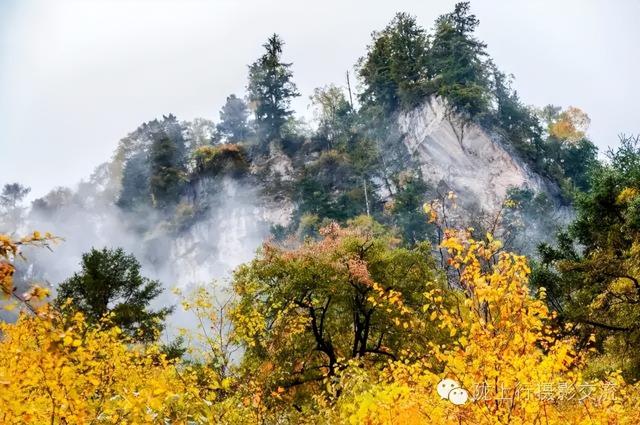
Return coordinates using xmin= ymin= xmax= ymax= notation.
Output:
xmin=0 ymin=0 xmax=640 ymax=198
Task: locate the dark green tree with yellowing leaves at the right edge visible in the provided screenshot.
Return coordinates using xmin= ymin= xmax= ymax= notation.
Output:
xmin=533 ymin=137 xmax=640 ymax=380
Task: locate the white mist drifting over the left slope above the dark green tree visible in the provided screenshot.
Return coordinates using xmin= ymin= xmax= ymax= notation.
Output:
xmin=8 ymin=171 xmax=280 ymax=333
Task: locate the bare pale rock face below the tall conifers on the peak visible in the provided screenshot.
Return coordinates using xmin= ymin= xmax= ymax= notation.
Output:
xmin=398 ymin=97 xmax=550 ymax=211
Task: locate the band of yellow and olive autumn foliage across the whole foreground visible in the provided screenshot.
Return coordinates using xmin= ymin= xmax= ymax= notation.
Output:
xmin=0 ymin=220 xmax=640 ymax=424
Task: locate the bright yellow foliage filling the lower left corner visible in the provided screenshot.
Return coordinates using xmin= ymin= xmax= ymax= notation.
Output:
xmin=0 ymin=232 xmax=225 ymax=424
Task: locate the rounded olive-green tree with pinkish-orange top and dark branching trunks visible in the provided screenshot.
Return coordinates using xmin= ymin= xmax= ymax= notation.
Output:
xmin=232 ymin=217 xmax=448 ymax=396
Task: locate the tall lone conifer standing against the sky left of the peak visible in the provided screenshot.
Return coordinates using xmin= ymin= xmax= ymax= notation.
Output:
xmin=247 ymin=34 xmax=300 ymax=142
